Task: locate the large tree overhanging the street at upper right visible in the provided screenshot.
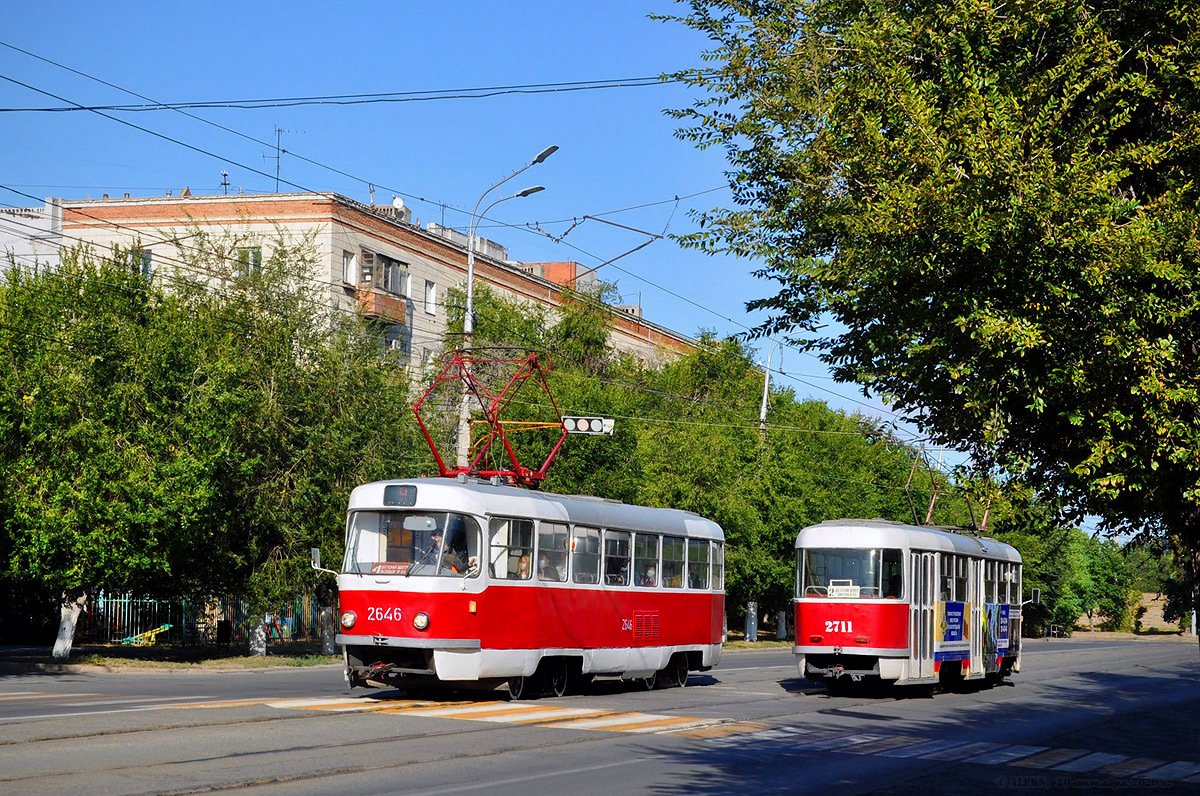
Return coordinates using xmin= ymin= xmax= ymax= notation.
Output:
xmin=674 ymin=0 xmax=1200 ymax=633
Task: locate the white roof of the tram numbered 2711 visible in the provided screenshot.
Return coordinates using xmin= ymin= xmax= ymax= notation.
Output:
xmin=796 ymin=520 xmax=1021 ymax=563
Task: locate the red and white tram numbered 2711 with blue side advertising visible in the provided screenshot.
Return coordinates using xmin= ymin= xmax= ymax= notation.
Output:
xmin=794 ymin=520 xmax=1021 ymax=689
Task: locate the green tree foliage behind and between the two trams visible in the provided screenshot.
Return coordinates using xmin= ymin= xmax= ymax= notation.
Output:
xmin=448 ymin=291 xmax=970 ymax=618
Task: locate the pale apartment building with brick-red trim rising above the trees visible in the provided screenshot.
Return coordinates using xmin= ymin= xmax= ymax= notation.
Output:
xmin=61 ymin=188 xmax=695 ymax=365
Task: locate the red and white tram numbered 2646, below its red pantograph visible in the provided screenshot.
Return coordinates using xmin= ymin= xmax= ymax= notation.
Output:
xmin=337 ymin=475 xmax=725 ymax=698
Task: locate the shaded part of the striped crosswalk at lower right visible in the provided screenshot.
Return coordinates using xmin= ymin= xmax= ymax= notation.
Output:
xmin=679 ymin=722 xmax=1200 ymax=783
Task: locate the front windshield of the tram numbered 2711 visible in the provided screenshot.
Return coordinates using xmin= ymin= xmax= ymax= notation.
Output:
xmin=797 ymin=549 xmax=904 ymax=599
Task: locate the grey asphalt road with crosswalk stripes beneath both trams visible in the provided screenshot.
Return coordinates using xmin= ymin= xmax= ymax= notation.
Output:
xmin=0 ymin=639 xmax=1200 ymax=796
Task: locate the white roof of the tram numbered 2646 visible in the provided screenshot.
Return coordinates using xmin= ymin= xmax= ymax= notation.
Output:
xmin=349 ymin=478 xmax=725 ymax=540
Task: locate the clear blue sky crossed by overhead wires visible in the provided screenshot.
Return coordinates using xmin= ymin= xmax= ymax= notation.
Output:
xmin=0 ymin=0 xmax=926 ymax=441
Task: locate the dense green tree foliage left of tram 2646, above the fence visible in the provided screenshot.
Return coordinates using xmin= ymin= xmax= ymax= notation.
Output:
xmin=0 ymin=231 xmax=427 ymax=633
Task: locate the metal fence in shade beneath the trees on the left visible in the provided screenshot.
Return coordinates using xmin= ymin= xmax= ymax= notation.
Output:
xmin=76 ymin=593 xmax=320 ymax=646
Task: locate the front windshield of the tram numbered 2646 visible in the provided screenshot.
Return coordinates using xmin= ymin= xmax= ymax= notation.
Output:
xmin=342 ymin=511 xmax=480 ymax=577
